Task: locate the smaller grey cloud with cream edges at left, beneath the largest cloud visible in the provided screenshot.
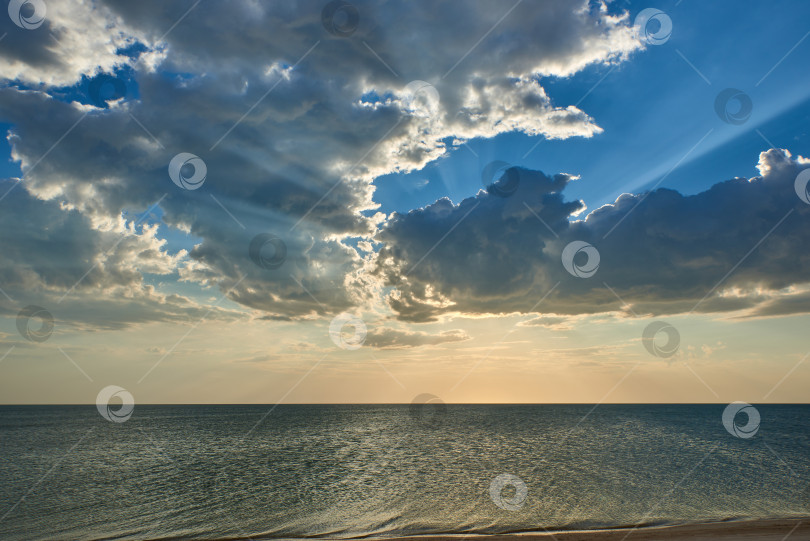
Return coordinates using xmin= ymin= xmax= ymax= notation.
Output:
xmin=0 ymin=180 xmax=246 ymax=330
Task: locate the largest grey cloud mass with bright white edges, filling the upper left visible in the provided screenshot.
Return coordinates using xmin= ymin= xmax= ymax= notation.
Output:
xmin=0 ymin=0 xmax=642 ymax=320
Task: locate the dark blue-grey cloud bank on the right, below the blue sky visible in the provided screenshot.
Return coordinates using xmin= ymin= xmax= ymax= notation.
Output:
xmin=376 ymin=149 xmax=810 ymax=322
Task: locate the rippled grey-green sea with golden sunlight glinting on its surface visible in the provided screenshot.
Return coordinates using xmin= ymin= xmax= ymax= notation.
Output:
xmin=0 ymin=404 xmax=810 ymax=540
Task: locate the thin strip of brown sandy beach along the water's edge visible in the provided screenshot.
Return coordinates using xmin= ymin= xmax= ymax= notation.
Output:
xmin=389 ymin=518 xmax=810 ymax=541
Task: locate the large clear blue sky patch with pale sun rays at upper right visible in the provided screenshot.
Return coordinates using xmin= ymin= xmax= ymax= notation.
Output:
xmin=375 ymin=1 xmax=810 ymax=212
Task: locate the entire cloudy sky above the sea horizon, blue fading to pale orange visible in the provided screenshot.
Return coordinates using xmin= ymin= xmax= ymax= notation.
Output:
xmin=0 ymin=0 xmax=810 ymax=404
